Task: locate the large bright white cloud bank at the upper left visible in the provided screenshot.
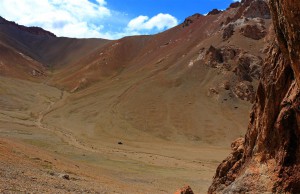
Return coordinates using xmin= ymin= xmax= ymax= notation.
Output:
xmin=0 ymin=0 xmax=111 ymax=38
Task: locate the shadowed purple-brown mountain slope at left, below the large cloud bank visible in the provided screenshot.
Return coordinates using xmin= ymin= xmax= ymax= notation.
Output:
xmin=0 ymin=17 xmax=108 ymax=81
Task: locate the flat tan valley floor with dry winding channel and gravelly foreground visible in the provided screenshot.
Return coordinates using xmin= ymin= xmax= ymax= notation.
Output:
xmin=0 ymin=78 xmax=239 ymax=193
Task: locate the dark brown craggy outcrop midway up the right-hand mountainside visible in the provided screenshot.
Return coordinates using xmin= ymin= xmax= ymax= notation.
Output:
xmin=204 ymin=46 xmax=263 ymax=103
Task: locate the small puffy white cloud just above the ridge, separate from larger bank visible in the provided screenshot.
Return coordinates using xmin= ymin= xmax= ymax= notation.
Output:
xmin=127 ymin=13 xmax=178 ymax=31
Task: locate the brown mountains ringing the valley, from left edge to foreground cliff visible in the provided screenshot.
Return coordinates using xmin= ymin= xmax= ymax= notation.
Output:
xmin=0 ymin=0 xmax=272 ymax=144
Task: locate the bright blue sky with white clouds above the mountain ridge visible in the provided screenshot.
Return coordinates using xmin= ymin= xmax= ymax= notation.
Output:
xmin=0 ymin=0 xmax=236 ymax=39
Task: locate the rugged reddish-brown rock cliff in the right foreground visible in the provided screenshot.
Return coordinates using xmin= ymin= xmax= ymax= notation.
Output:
xmin=208 ymin=0 xmax=300 ymax=193
